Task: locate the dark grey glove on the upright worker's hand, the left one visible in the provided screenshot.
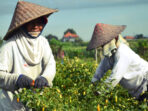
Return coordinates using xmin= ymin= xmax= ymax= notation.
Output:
xmin=16 ymin=74 xmax=33 ymax=88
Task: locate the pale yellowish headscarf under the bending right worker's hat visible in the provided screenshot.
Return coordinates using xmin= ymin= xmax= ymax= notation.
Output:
xmin=100 ymin=34 xmax=129 ymax=58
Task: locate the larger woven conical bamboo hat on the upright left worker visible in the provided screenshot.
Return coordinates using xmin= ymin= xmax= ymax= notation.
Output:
xmin=4 ymin=1 xmax=58 ymax=40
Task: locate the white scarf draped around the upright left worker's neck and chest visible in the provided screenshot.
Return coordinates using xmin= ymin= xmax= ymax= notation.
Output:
xmin=15 ymin=30 xmax=44 ymax=65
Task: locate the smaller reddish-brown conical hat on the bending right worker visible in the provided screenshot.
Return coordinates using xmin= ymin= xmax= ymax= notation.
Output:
xmin=86 ymin=23 xmax=126 ymax=50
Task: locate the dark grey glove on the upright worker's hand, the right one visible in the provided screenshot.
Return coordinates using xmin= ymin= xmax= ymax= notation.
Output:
xmin=35 ymin=76 xmax=49 ymax=88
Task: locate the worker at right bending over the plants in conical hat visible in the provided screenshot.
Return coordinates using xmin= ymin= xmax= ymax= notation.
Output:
xmin=87 ymin=23 xmax=148 ymax=99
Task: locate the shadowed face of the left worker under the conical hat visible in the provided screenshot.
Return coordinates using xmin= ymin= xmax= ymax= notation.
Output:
xmin=26 ymin=19 xmax=44 ymax=32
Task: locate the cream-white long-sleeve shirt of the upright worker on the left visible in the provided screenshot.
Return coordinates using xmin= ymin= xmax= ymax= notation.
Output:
xmin=0 ymin=36 xmax=56 ymax=111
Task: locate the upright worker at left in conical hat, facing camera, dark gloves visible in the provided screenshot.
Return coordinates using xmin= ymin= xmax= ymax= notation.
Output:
xmin=0 ymin=1 xmax=57 ymax=111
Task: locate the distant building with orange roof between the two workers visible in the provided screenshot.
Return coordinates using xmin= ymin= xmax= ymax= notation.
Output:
xmin=62 ymin=32 xmax=79 ymax=42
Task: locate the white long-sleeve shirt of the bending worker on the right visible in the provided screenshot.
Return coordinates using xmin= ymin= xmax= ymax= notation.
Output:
xmin=92 ymin=43 xmax=148 ymax=98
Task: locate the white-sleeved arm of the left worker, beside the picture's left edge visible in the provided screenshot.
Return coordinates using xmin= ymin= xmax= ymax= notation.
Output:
xmin=0 ymin=45 xmax=19 ymax=91
